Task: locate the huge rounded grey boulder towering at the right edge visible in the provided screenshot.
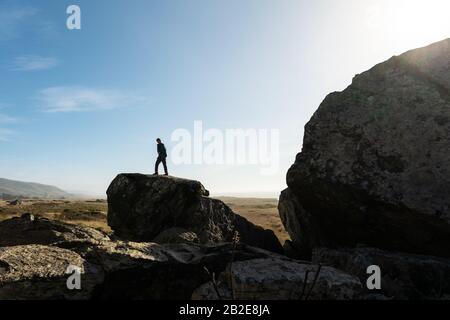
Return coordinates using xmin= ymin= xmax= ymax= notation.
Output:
xmin=279 ymin=39 xmax=450 ymax=257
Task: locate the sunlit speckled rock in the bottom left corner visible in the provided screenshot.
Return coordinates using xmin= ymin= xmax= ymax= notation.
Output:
xmin=0 ymin=245 xmax=104 ymax=300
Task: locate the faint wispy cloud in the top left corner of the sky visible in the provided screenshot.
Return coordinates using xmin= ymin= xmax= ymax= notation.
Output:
xmin=0 ymin=6 xmax=38 ymax=40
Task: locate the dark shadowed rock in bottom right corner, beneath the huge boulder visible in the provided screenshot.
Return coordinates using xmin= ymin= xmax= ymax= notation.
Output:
xmin=313 ymin=248 xmax=450 ymax=300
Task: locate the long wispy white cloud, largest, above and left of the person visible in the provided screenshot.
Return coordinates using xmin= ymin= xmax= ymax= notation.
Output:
xmin=37 ymin=87 xmax=148 ymax=112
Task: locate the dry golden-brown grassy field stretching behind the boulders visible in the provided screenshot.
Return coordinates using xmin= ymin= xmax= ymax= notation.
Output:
xmin=0 ymin=198 xmax=289 ymax=243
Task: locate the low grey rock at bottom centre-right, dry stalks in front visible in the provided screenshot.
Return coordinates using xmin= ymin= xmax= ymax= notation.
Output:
xmin=192 ymin=257 xmax=361 ymax=300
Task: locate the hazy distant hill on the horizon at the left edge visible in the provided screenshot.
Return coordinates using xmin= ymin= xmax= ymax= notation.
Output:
xmin=0 ymin=178 xmax=72 ymax=199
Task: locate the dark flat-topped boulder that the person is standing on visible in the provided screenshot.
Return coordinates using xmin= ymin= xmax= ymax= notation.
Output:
xmin=107 ymin=174 xmax=282 ymax=252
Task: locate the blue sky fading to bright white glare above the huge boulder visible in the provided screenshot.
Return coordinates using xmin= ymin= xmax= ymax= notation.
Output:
xmin=0 ymin=0 xmax=450 ymax=195
